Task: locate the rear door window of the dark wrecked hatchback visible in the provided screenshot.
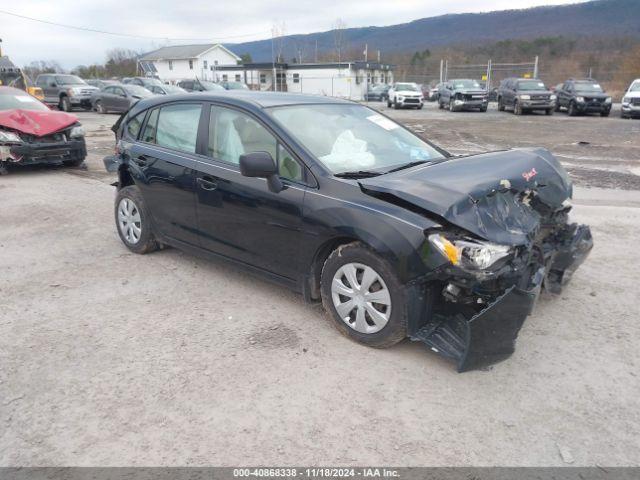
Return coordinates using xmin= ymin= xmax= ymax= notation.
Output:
xmin=142 ymin=104 xmax=202 ymax=153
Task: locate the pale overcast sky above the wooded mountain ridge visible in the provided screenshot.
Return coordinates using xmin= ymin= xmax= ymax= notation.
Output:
xmin=0 ymin=0 xmax=584 ymax=68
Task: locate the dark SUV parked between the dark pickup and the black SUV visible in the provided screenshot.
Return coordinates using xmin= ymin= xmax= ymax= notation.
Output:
xmin=498 ymin=78 xmax=556 ymax=115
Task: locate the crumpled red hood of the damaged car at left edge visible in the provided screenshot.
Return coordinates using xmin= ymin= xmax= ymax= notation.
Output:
xmin=0 ymin=109 xmax=78 ymax=137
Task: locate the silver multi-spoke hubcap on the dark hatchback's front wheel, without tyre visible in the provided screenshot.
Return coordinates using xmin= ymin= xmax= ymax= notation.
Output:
xmin=331 ymin=263 xmax=391 ymax=334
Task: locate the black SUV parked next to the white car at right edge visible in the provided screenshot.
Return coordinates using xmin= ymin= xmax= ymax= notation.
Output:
xmin=556 ymin=79 xmax=611 ymax=117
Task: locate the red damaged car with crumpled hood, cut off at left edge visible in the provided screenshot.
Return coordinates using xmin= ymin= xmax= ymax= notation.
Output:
xmin=0 ymin=87 xmax=87 ymax=175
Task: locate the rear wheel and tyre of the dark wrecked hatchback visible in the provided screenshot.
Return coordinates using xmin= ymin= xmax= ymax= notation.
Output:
xmin=115 ymin=185 xmax=158 ymax=254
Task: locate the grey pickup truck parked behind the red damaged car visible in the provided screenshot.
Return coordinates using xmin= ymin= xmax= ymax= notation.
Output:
xmin=36 ymin=73 xmax=98 ymax=112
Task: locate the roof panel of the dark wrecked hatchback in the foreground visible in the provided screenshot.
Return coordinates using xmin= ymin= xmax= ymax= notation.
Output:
xmin=131 ymin=90 xmax=353 ymax=108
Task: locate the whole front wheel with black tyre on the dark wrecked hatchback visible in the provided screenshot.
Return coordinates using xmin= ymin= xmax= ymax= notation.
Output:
xmin=321 ymin=242 xmax=407 ymax=348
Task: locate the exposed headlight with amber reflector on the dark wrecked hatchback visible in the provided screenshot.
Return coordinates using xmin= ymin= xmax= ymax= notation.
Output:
xmin=429 ymin=233 xmax=511 ymax=270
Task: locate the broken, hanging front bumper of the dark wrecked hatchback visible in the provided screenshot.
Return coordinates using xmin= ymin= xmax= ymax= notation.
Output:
xmin=410 ymin=225 xmax=593 ymax=372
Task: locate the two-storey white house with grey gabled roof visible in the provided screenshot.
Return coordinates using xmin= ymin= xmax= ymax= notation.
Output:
xmin=138 ymin=43 xmax=240 ymax=83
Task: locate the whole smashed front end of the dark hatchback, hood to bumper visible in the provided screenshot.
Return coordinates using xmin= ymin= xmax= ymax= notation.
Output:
xmin=362 ymin=146 xmax=593 ymax=372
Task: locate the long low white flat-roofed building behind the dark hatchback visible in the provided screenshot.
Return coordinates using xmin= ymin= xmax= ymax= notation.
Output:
xmin=215 ymin=61 xmax=393 ymax=100
